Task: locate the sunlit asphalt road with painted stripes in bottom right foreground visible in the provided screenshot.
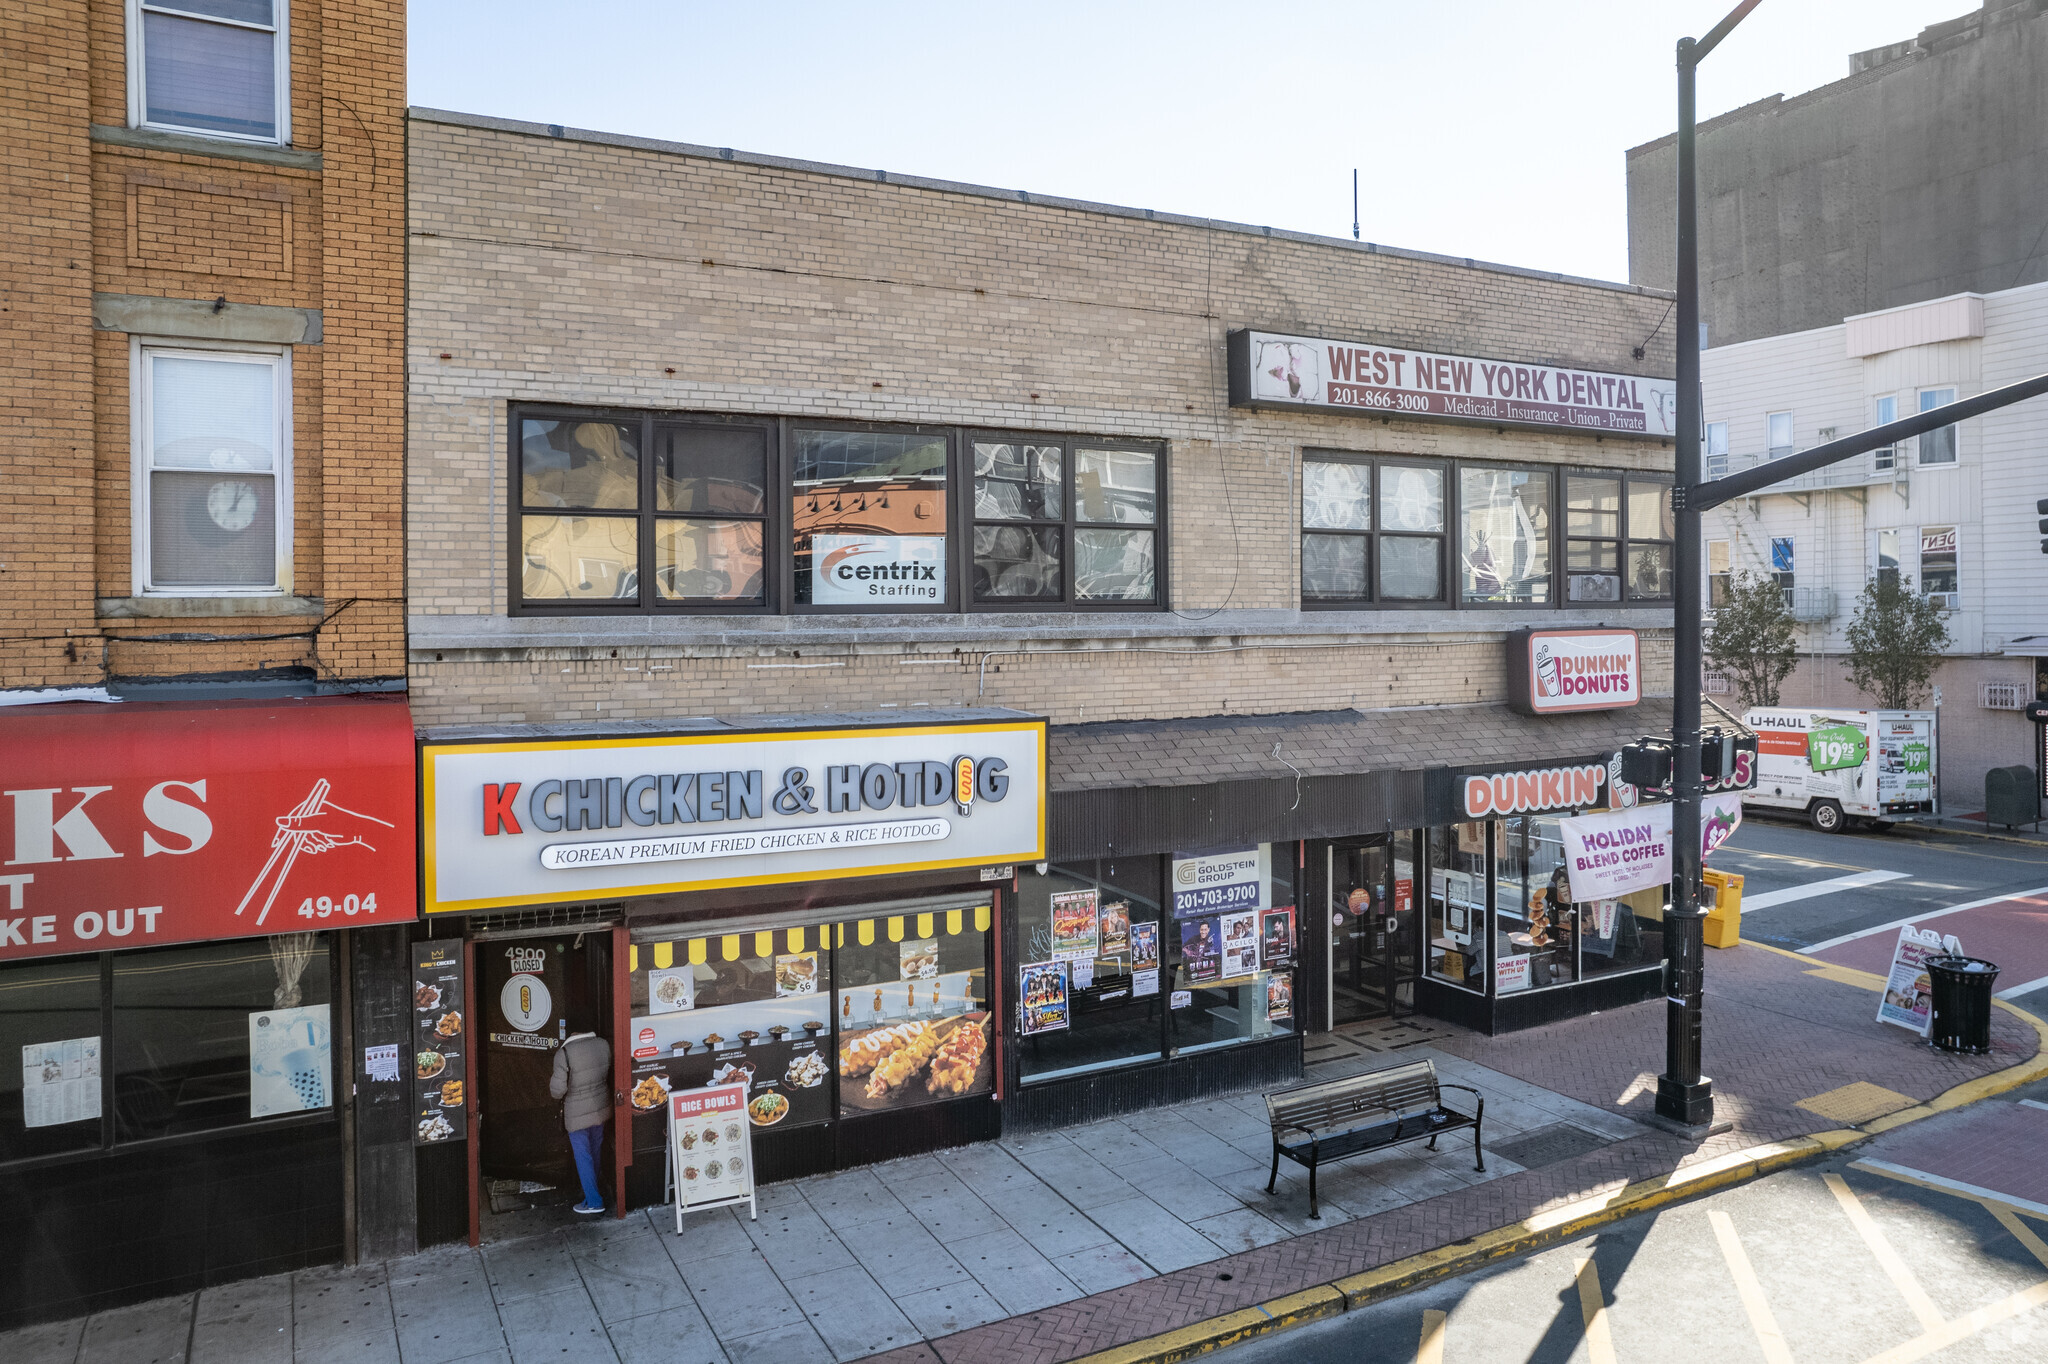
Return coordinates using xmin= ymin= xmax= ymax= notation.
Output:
xmin=1221 ymin=1085 xmax=2048 ymax=1364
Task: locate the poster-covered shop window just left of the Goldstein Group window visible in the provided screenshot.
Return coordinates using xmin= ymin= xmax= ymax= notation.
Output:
xmin=1016 ymin=856 xmax=1165 ymax=1083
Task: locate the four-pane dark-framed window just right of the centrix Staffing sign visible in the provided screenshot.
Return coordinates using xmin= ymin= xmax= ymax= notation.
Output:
xmin=969 ymin=434 xmax=1159 ymax=606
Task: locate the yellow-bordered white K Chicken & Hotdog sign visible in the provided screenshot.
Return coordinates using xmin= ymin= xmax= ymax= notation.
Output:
xmin=420 ymin=721 xmax=1044 ymax=913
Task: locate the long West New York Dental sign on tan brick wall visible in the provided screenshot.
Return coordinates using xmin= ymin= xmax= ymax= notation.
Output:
xmin=1229 ymin=330 xmax=1677 ymax=438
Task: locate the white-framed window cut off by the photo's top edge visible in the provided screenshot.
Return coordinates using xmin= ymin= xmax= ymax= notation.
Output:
xmin=129 ymin=0 xmax=291 ymax=143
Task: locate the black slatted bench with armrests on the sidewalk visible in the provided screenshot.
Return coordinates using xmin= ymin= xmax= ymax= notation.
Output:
xmin=1266 ymin=1061 xmax=1487 ymax=1219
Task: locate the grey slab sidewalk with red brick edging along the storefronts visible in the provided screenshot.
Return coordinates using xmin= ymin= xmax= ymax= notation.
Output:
xmin=12 ymin=948 xmax=2040 ymax=1364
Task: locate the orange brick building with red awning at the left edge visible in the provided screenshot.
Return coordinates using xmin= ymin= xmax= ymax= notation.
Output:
xmin=0 ymin=0 xmax=416 ymax=1323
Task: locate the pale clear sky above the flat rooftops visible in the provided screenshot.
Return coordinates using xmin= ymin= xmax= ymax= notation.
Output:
xmin=410 ymin=0 xmax=1976 ymax=279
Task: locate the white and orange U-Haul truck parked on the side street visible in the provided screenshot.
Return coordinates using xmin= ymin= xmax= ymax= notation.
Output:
xmin=1743 ymin=707 xmax=1939 ymax=834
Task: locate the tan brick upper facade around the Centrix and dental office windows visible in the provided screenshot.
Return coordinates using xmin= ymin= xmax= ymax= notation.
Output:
xmin=408 ymin=111 xmax=1673 ymax=725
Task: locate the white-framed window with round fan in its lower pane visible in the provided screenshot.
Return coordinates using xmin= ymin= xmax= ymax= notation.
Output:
xmin=133 ymin=344 xmax=291 ymax=596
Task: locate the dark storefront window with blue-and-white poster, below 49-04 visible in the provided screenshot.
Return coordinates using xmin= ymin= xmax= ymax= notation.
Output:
xmin=113 ymin=934 xmax=334 ymax=1141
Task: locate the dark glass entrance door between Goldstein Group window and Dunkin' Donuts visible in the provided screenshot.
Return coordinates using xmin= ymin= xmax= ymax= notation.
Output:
xmin=1325 ymin=834 xmax=1419 ymax=1026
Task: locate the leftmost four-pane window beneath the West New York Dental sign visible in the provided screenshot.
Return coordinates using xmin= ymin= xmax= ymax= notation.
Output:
xmin=1300 ymin=451 xmax=1448 ymax=606
